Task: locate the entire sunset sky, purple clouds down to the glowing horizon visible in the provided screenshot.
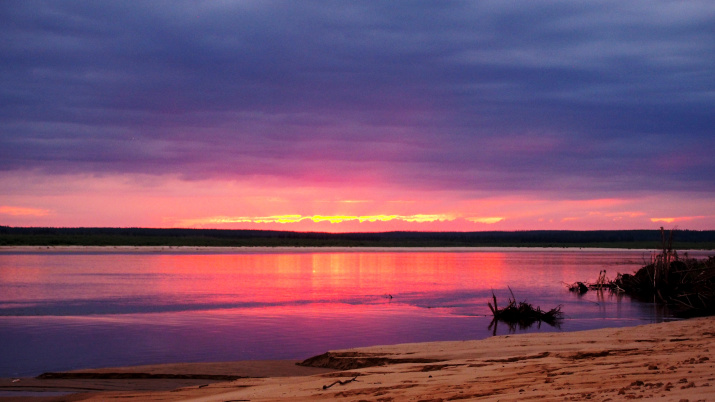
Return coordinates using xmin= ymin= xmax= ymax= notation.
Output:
xmin=0 ymin=0 xmax=715 ymax=232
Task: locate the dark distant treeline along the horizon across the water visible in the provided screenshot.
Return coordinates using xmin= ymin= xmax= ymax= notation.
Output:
xmin=0 ymin=226 xmax=715 ymax=250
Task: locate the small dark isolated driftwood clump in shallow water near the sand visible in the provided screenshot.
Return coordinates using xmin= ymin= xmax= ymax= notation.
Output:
xmin=487 ymin=288 xmax=563 ymax=333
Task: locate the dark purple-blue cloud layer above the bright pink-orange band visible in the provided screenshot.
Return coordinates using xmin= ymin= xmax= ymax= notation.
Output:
xmin=0 ymin=0 xmax=715 ymax=192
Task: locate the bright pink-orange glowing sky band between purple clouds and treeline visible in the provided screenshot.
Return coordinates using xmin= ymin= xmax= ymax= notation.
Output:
xmin=0 ymin=173 xmax=715 ymax=232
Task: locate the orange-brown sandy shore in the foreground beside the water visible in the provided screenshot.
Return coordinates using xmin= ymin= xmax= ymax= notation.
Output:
xmin=0 ymin=317 xmax=715 ymax=401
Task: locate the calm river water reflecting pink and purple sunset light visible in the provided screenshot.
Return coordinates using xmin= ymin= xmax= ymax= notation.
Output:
xmin=0 ymin=249 xmax=707 ymax=377
